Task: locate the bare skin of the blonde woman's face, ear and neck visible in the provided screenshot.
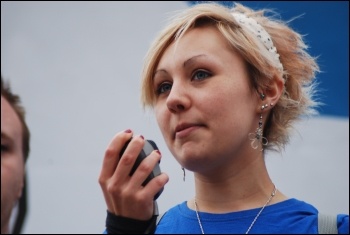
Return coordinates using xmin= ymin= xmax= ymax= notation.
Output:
xmin=154 ymin=27 xmax=287 ymax=213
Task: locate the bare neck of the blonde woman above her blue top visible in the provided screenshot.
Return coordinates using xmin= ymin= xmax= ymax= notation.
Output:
xmin=188 ymin=156 xmax=287 ymax=213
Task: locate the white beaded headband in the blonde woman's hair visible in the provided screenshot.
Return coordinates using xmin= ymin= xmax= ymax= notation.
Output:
xmin=232 ymin=12 xmax=283 ymax=72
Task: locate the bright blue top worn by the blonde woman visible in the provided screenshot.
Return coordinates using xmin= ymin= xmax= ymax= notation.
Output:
xmin=155 ymin=198 xmax=349 ymax=234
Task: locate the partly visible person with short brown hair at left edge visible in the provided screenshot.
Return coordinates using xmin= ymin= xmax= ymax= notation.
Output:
xmin=1 ymin=77 xmax=30 ymax=234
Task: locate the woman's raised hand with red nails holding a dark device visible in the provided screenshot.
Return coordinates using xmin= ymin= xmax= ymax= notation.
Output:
xmin=99 ymin=130 xmax=169 ymax=220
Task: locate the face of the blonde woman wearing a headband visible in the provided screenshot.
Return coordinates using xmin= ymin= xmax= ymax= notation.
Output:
xmin=153 ymin=26 xmax=258 ymax=171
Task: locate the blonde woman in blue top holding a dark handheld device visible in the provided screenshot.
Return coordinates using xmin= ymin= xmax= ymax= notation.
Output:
xmin=99 ymin=3 xmax=349 ymax=234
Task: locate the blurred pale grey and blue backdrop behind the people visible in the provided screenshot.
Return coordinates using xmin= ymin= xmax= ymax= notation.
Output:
xmin=1 ymin=1 xmax=349 ymax=234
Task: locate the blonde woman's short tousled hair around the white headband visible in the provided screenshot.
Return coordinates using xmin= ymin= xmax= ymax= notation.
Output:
xmin=141 ymin=3 xmax=319 ymax=150
